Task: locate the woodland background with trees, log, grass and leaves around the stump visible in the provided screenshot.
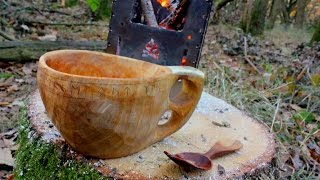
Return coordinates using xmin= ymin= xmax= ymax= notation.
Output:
xmin=0 ymin=0 xmax=320 ymax=179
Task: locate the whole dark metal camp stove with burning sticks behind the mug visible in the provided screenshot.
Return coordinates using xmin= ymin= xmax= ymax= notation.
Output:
xmin=107 ymin=0 xmax=213 ymax=67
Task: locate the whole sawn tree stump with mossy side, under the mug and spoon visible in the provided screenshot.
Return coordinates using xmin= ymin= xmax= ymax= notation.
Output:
xmin=26 ymin=90 xmax=279 ymax=179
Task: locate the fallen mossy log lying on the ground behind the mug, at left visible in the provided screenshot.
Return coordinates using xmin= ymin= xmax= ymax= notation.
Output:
xmin=0 ymin=41 xmax=107 ymax=62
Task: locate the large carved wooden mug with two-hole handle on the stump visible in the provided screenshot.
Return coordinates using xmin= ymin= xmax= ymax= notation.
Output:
xmin=37 ymin=50 xmax=204 ymax=158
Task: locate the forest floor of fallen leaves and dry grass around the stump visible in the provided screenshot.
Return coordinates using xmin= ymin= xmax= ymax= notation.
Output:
xmin=0 ymin=0 xmax=320 ymax=179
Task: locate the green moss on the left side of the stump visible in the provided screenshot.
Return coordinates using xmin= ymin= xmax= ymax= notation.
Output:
xmin=14 ymin=108 xmax=103 ymax=180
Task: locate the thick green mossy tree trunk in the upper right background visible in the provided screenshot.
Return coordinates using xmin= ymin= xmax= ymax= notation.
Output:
xmin=241 ymin=0 xmax=268 ymax=35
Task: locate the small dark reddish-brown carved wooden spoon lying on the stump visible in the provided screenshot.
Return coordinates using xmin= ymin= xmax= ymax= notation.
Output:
xmin=164 ymin=140 xmax=242 ymax=170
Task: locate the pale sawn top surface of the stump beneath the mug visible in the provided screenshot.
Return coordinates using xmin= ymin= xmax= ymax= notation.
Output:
xmin=28 ymin=90 xmax=275 ymax=179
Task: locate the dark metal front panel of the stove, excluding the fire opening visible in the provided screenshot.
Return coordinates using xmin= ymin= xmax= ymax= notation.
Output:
xmin=107 ymin=0 xmax=213 ymax=67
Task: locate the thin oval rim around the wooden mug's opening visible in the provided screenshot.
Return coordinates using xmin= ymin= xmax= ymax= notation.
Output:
xmin=39 ymin=49 xmax=172 ymax=84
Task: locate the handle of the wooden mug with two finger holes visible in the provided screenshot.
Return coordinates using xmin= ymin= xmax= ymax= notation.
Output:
xmin=156 ymin=66 xmax=204 ymax=141
